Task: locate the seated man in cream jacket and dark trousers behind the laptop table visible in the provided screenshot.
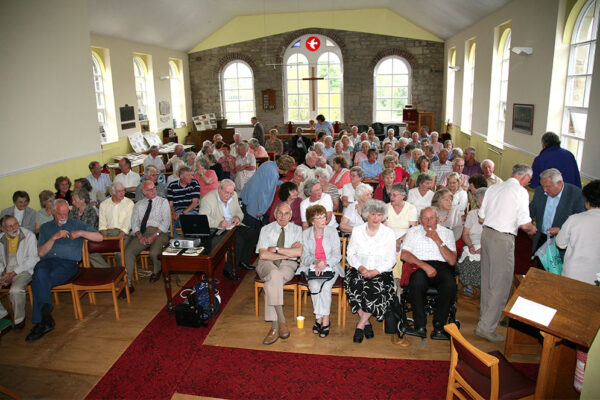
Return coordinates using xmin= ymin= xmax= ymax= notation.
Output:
xmin=200 ymin=179 xmax=259 ymax=281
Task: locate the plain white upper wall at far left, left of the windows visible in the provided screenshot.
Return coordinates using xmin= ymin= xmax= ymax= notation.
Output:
xmin=0 ymin=0 xmax=101 ymax=176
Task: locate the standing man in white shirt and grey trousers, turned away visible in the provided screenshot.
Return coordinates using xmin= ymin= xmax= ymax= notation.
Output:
xmin=475 ymin=164 xmax=537 ymax=342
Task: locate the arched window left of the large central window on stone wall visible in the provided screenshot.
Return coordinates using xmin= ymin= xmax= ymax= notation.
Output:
xmin=221 ymin=60 xmax=255 ymax=124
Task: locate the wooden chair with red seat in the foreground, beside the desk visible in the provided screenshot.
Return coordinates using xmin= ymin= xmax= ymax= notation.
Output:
xmin=444 ymin=324 xmax=535 ymax=400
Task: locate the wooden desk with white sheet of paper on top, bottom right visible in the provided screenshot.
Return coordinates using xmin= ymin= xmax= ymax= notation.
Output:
xmin=502 ymin=268 xmax=600 ymax=399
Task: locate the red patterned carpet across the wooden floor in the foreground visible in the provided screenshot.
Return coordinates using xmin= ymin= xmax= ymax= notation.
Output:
xmin=87 ymin=256 xmax=538 ymax=399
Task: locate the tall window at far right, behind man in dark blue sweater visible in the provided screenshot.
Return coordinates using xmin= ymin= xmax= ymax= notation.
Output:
xmin=561 ymin=0 xmax=600 ymax=164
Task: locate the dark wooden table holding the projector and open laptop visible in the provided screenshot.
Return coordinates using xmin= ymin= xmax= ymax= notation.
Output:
xmin=160 ymin=228 xmax=236 ymax=316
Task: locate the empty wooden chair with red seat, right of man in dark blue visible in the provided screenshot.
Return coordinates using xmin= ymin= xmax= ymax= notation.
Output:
xmin=73 ymin=237 xmax=130 ymax=320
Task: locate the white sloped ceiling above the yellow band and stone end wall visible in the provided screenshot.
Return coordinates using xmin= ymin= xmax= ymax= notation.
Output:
xmin=87 ymin=0 xmax=510 ymax=51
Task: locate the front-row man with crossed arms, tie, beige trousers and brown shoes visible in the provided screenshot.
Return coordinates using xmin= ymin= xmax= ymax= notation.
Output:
xmin=256 ymin=203 xmax=302 ymax=345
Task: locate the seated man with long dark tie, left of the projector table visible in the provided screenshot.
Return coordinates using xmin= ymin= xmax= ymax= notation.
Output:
xmin=119 ymin=181 xmax=171 ymax=290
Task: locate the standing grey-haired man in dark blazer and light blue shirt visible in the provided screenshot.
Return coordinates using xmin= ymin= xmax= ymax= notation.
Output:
xmin=529 ymin=168 xmax=586 ymax=268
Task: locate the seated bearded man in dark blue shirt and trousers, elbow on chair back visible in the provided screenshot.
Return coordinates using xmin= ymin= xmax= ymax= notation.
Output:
xmin=25 ymin=199 xmax=102 ymax=342
